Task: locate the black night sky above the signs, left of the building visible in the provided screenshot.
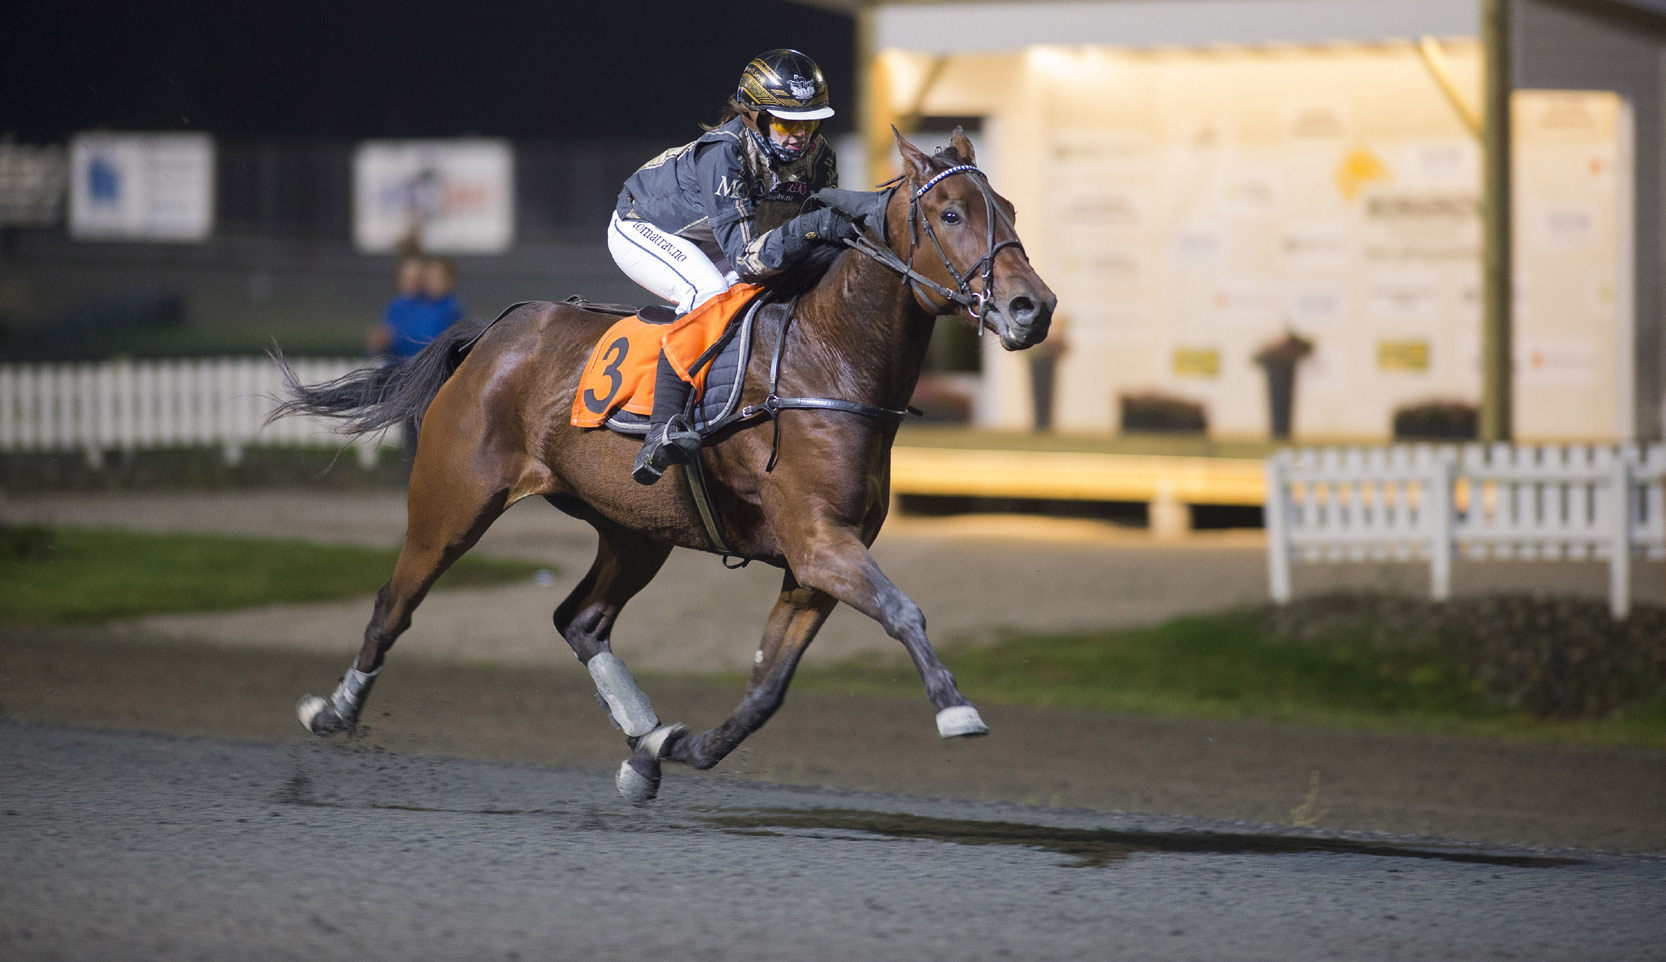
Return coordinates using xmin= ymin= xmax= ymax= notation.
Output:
xmin=0 ymin=0 xmax=855 ymax=143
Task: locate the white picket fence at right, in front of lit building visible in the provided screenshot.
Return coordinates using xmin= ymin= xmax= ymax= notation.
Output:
xmin=1266 ymin=445 xmax=1666 ymax=619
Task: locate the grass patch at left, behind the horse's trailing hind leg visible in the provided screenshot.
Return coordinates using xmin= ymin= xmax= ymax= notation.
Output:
xmin=0 ymin=529 xmax=540 ymax=625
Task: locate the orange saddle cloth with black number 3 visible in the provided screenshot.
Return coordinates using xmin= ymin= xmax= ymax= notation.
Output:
xmin=573 ymin=283 xmax=763 ymax=427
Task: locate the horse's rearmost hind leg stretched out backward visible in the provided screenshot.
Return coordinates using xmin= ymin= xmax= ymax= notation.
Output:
xmin=295 ymin=443 xmax=510 ymax=735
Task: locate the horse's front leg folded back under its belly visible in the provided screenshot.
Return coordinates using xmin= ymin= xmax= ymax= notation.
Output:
xmin=618 ymin=574 xmax=838 ymax=805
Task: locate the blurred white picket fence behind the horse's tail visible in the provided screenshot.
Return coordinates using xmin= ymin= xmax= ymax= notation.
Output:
xmin=0 ymin=357 xmax=389 ymax=467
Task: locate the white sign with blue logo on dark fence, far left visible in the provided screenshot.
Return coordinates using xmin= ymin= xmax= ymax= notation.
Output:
xmin=70 ymin=133 xmax=213 ymax=242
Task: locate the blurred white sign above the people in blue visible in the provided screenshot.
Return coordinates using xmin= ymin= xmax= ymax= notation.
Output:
xmin=353 ymin=140 xmax=515 ymax=253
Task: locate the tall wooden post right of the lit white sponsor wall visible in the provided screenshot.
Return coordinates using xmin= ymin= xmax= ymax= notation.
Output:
xmin=1479 ymin=0 xmax=1514 ymax=442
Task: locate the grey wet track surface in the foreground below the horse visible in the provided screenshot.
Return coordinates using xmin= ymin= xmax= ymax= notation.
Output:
xmin=0 ymin=722 xmax=1666 ymax=960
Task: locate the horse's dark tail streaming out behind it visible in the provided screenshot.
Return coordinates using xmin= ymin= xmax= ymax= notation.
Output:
xmin=267 ymin=313 xmax=493 ymax=437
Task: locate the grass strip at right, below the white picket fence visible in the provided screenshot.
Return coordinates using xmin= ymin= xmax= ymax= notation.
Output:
xmin=796 ymin=610 xmax=1666 ymax=749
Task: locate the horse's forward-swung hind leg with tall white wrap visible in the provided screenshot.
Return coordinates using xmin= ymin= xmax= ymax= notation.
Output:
xmin=555 ymin=517 xmax=671 ymax=739
